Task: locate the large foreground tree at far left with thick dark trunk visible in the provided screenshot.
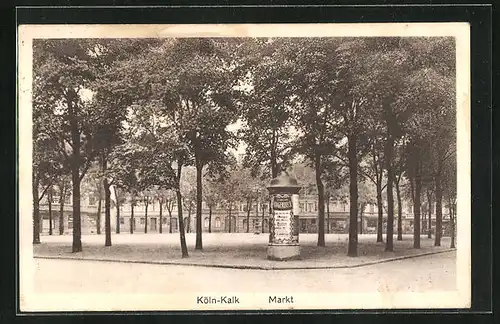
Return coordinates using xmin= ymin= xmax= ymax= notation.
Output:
xmin=33 ymin=39 xmax=105 ymax=252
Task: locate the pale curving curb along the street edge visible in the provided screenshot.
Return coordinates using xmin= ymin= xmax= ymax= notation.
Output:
xmin=33 ymin=249 xmax=456 ymax=270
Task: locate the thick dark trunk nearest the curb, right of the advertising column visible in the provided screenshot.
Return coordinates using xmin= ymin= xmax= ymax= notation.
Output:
xmin=347 ymin=135 xmax=358 ymax=256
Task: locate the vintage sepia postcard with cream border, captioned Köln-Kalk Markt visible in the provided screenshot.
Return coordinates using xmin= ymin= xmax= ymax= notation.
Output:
xmin=18 ymin=23 xmax=471 ymax=312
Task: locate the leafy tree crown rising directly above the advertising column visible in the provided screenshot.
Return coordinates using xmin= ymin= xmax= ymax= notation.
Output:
xmin=239 ymin=39 xmax=295 ymax=179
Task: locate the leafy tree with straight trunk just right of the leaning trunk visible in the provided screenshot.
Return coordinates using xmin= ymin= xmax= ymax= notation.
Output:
xmin=131 ymin=39 xmax=242 ymax=249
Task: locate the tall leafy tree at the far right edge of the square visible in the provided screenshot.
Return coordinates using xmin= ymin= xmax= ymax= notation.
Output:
xmin=398 ymin=37 xmax=455 ymax=245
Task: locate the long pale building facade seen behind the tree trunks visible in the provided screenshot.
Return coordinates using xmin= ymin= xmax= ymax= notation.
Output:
xmin=40 ymin=194 xmax=449 ymax=235
